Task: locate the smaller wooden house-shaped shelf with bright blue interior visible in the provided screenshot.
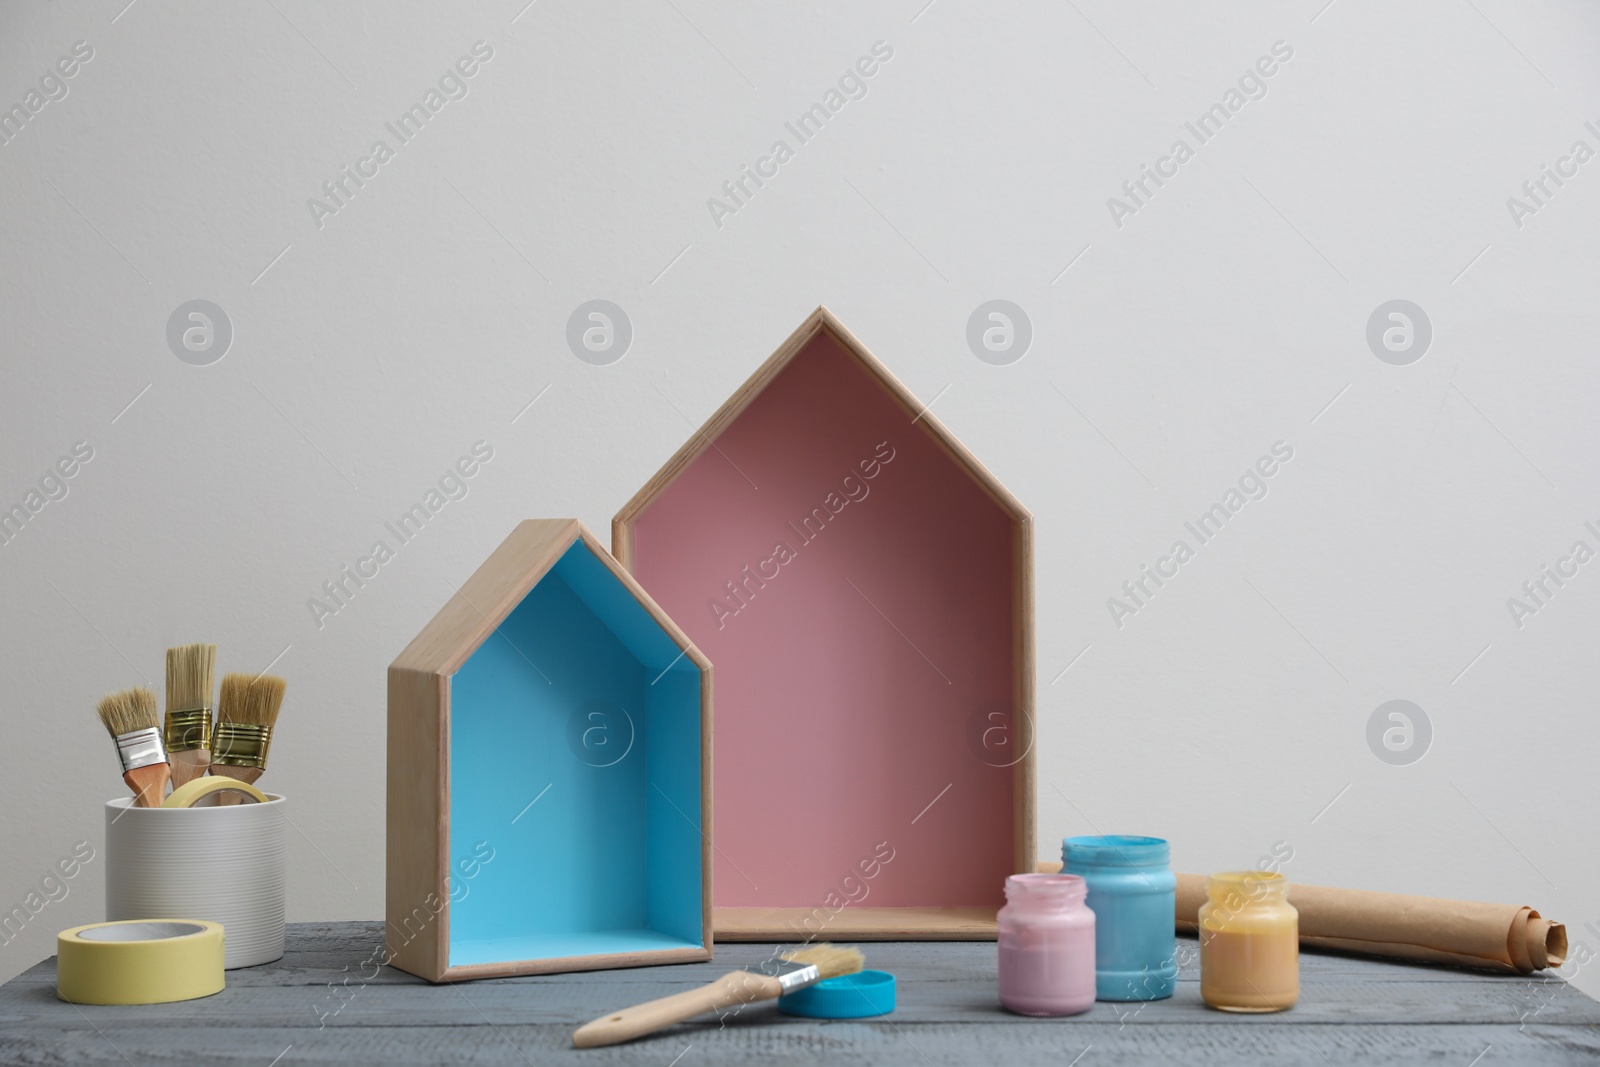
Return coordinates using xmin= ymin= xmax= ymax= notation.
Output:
xmin=386 ymin=518 xmax=712 ymax=982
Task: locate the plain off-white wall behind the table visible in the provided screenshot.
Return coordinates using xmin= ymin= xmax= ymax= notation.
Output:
xmin=0 ymin=0 xmax=1600 ymax=1016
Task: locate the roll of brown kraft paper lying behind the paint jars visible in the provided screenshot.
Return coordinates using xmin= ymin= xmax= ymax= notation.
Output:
xmin=1178 ymin=875 xmax=1566 ymax=974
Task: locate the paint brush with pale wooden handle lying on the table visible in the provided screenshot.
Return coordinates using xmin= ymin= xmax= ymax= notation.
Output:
xmin=573 ymin=944 xmax=866 ymax=1048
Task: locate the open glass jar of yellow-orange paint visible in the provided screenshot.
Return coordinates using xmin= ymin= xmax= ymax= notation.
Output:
xmin=1197 ymin=870 xmax=1299 ymax=1011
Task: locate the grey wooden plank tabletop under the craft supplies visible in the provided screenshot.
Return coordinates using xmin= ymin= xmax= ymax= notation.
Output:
xmin=0 ymin=923 xmax=1600 ymax=1067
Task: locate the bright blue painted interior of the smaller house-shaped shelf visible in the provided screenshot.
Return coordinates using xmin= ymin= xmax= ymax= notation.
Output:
xmin=448 ymin=539 xmax=702 ymax=966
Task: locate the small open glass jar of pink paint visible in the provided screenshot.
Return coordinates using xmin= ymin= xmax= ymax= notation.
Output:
xmin=998 ymin=875 xmax=1094 ymax=1016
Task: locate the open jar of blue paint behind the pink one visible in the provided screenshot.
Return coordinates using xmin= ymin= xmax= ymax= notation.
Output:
xmin=1061 ymin=835 xmax=1178 ymax=1000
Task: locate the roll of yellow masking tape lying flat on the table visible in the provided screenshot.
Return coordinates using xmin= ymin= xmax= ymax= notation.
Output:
xmin=56 ymin=918 xmax=222 ymax=1005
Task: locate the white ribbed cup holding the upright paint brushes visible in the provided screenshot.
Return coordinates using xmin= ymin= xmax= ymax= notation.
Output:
xmin=106 ymin=793 xmax=286 ymax=969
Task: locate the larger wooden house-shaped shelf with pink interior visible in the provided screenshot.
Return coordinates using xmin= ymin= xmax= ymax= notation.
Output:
xmin=613 ymin=309 xmax=1034 ymax=941
